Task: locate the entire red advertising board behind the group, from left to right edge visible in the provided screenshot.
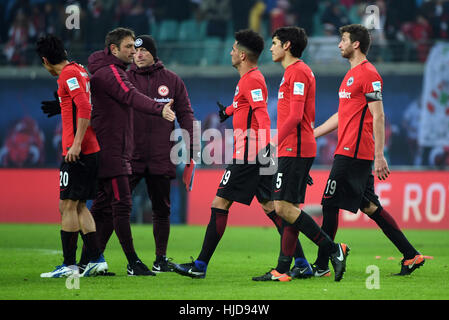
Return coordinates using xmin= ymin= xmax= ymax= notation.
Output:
xmin=0 ymin=169 xmax=449 ymax=229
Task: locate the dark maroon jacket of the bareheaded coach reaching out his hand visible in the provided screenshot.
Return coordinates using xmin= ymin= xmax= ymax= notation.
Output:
xmin=88 ymin=49 xmax=164 ymax=178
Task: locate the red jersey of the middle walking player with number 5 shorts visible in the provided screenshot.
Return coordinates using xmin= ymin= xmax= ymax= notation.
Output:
xmin=277 ymin=60 xmax=316 ymax=158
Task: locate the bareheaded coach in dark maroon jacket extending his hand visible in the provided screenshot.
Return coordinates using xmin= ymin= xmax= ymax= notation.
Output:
xmin=88 ymin=28 xmax=175 ymax=275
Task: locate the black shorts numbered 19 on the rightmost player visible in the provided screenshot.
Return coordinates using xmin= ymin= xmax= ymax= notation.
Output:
xmin=321 ymin=155 xmax=380 ymax=213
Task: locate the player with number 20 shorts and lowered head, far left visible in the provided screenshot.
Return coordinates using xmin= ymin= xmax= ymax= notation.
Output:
xmin=36 ymin=35 xmax=107 ymax=278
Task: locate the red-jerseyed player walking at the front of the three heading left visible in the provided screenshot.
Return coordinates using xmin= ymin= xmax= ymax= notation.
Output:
xmin=175 ymin=30 xmax=311 ymax=278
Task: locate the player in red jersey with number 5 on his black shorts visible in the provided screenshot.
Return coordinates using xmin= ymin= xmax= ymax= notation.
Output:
xmin=253 ymin=27 xmax=349 ymax=281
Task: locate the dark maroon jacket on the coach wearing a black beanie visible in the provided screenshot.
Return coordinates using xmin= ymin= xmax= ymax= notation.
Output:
xmin=127 ymin=61 xmax=194 ymax=178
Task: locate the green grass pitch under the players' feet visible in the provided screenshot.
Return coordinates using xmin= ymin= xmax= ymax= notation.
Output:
xmin=0 ymin=224 xmax=449 ymax=300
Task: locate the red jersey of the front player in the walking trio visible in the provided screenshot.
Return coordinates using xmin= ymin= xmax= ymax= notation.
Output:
xmin=228 ymin=67 xmax=271 ymax=161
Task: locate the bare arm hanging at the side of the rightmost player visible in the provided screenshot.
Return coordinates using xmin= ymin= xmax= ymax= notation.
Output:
xmin=368 ymin=101 xmax=390 ymax=180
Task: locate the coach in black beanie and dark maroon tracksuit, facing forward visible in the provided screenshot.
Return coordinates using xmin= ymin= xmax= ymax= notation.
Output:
xmin=127 ymin=35 xmax=194 ymax=272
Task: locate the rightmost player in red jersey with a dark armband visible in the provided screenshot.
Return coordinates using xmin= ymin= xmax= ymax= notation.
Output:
xmin=314 ymin=25 xmax=424 ymax=276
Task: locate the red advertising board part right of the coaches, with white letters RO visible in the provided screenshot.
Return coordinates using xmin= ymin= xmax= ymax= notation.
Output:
xmin=187 ymin=170 xmax=449 ymax=229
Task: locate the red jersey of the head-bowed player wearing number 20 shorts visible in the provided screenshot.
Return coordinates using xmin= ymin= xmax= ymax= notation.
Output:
xmin=58 ymin=62 xmax=100 ymax=156
